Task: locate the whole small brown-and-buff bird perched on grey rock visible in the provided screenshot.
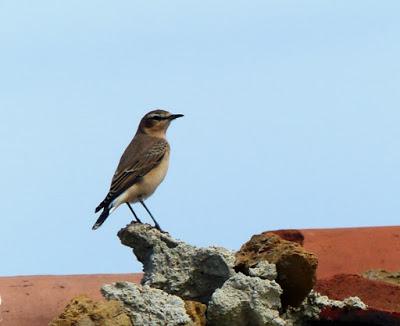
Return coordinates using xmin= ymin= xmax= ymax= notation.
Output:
xmin=92 ymin=109 xmax=183 ymax=231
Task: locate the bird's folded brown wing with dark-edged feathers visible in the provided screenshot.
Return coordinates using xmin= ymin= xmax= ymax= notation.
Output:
xmin=96 ymin=139 xmax=168 ymax=211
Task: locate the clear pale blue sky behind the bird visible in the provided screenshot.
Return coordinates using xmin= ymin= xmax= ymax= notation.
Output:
xmin=0 ymin=0 xmax=400 ymax=275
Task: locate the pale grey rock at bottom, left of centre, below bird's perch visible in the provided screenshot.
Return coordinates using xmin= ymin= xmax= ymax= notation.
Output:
xmin=101 ymin=282 xmax=193 ymax=326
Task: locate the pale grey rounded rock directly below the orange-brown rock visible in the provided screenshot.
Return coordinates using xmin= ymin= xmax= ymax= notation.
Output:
xmin=207 ymin=273 xmax=286 ymax=326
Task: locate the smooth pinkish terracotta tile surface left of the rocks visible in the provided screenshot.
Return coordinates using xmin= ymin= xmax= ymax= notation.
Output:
xmin=0 ymin=274 xmax=142 ymax=326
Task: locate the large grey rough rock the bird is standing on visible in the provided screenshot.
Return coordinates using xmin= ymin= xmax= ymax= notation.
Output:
xmin=118 ymin=223 xmax=235 ymax=303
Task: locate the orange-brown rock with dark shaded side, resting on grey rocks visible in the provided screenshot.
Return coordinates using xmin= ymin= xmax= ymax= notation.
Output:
xmin=235 ymin=232 xmax=318 ymax=308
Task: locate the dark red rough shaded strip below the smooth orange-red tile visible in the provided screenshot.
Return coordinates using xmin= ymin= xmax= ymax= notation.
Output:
xmin=314 ymin=274 xmax=400 ymax=313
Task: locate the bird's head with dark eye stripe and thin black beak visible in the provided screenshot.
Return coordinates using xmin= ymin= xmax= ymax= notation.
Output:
xmin=139 ymin=110 xmax=183 ymax=137
